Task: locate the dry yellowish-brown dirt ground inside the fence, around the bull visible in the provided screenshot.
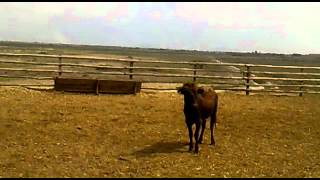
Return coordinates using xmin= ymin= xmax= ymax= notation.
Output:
xmin=0 ymin=87 xmax=320 ymax=177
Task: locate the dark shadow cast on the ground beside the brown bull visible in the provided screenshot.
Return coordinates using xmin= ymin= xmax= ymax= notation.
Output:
xmin=132 ymin=141 xmax=188 ymax=157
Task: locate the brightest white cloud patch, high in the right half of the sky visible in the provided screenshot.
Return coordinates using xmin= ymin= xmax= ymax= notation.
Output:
xmin=175 ymin=2 xmax=286 ymax=30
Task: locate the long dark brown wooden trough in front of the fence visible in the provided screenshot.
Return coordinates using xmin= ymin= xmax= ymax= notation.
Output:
xmin=54 ymin=77 xmax=141 ymax=94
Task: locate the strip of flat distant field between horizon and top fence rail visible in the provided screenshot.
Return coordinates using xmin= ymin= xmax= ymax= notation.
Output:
xmin=0 ymin=42 xmax=320 ymax=66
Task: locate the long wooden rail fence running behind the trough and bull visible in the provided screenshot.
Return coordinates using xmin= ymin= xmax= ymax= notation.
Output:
xmin=0 ymin=53 xmax=320 ymax=96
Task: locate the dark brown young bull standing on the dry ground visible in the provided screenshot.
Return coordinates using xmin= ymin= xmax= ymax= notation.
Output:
xmin=178 ymin=83 xmax=218 ymax=153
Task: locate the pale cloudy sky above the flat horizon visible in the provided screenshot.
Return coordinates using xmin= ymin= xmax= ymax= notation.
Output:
xmin=0 ymin=2 xmax=320 ymax=54
